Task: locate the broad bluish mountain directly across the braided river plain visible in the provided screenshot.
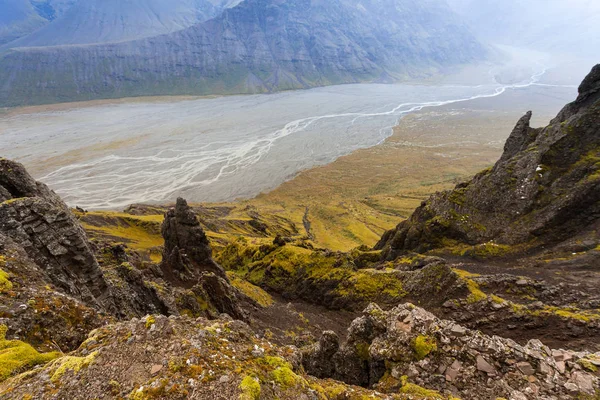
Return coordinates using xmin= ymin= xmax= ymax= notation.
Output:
xmin=0 ymin=0 xmax=486 ymax=106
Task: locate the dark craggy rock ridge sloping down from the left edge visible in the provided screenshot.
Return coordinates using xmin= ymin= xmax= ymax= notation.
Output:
xmin=0 ymin=159 xmax=114 ymax=310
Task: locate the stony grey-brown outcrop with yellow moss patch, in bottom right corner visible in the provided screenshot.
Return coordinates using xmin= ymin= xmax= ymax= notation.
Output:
xmin=303 ymin=303 xmax=600 ymax=400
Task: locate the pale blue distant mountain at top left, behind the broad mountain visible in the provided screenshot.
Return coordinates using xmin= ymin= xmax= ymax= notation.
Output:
xmin=5 ymin=0 xmax=225 ymax=48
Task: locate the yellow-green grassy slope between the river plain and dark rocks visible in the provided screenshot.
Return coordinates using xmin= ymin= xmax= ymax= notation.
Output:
xmin=77 ymin=112 xmax=514 ymax=252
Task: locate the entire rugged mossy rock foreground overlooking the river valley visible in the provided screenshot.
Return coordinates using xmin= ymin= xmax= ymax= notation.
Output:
xmin=0 ymin=66 xmax=600 ymax=400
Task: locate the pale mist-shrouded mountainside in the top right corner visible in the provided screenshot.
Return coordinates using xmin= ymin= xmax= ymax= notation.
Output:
xmin=448 ymin=0 xmax=600 ymax=54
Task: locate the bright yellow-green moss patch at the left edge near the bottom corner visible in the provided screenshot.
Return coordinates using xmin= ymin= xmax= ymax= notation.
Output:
xmin=0 ymin=325 xmax=60 ymax=382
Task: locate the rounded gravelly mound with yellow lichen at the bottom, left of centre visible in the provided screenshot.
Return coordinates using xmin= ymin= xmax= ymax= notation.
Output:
xmin=0 ymin=315 xmax=420 ymax=400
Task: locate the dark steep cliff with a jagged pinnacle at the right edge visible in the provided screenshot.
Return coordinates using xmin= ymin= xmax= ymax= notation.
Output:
xmin=376 ymin=65 xmax=600 ymax=259
